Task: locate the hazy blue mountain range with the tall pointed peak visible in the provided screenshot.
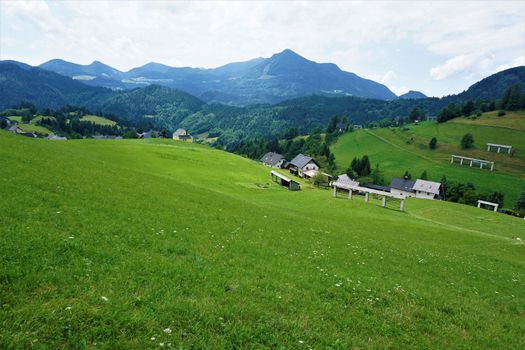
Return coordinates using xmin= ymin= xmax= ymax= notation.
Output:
xmin=39 ymin=49 xmax=396 ymax=105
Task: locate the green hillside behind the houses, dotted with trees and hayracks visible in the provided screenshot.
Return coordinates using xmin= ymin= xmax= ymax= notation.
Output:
xmin=332 ymin=110 xmax=525 ymax=207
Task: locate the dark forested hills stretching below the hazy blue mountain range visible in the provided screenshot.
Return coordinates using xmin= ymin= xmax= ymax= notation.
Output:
xmin=0 ymin=62 xmax=525 ymax=144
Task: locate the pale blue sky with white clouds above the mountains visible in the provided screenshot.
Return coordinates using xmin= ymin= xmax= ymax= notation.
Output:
xmin=0 ymin=0 xmax=525 ymax=96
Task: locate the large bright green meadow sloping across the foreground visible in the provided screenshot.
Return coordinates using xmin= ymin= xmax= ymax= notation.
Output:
xmin=0 ymin=132 xmax=525 ymax=349
